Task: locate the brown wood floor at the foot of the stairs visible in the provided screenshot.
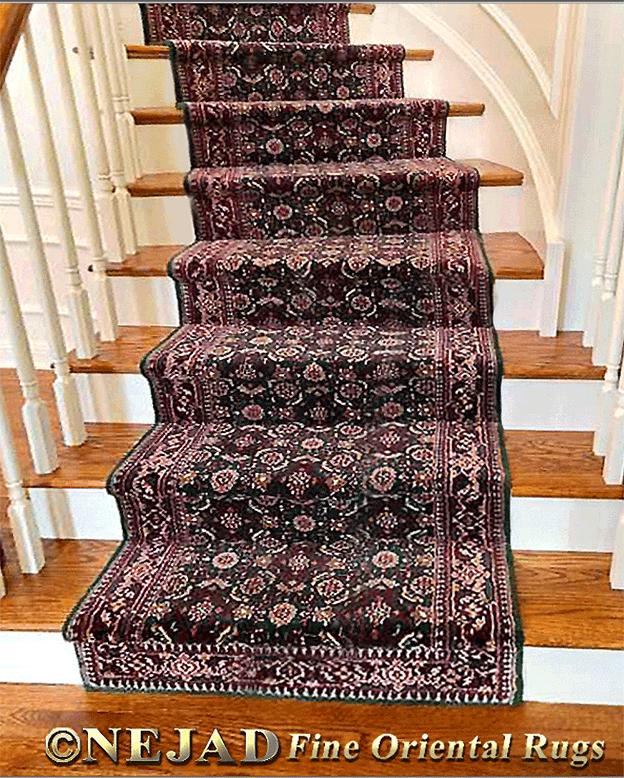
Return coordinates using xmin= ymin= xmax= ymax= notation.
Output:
xmin=0 ymin=684 xmax=624 ymax=776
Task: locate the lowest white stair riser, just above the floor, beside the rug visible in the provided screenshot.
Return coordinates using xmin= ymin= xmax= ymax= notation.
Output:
xmin=0 ymin=631 xmax=624 ymax=705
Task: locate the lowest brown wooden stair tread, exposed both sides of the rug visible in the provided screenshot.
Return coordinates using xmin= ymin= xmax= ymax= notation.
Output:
xmin=0 ymin=540 xmax=624 ymax=649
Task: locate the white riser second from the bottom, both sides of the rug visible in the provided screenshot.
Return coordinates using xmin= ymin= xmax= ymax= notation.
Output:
xmin=29 ymin=488 xmax=622 ymax=552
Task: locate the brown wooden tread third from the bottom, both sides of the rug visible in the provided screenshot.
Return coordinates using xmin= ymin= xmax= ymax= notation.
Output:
xmin=69 ymin=325 xmax=604 ymax=380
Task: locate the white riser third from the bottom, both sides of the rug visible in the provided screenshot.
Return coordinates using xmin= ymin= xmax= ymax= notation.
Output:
xmin=75 ymin=373 xmax=602 ymax=431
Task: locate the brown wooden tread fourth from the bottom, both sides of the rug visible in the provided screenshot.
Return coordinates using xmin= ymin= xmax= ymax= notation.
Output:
xmin=106 ymin=232 xmax=544 ymax=280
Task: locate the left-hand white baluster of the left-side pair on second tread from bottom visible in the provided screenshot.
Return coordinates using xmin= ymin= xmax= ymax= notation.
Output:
xmin=0 ymin=221 xmax=58 ymax=474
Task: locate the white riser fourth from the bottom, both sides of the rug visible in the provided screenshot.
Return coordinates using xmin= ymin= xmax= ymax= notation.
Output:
xmin=111 ymin=276 xmax=542 ymax=330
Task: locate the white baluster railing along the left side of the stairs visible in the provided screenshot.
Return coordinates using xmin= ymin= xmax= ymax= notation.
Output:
xmin=0 ymin=3 xmax=140 ymax=596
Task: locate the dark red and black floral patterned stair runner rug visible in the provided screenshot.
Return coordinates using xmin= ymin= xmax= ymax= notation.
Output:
xmin=64 ymin=4 xmax=522 ymax=704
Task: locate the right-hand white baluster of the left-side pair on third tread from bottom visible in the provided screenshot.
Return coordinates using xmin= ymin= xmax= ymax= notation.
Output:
xmin=47 ymin=3 xmax=117 ymax=341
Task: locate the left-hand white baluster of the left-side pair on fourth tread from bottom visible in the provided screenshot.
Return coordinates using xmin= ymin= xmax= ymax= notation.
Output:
xmin=72 ymin=3 xmax=126 ymax=262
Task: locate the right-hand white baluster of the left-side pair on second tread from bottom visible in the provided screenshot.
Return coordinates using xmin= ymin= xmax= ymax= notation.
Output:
xmin=0 ymin=84 xmax=86 ymax=446
